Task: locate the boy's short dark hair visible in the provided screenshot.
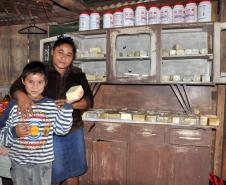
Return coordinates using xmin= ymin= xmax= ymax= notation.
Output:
xmin=21 ymin=61 xmax=48 ymax=82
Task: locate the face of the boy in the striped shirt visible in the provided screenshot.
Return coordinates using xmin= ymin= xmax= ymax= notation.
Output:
xmin=22 ymin=73 xmax=46 ymax=100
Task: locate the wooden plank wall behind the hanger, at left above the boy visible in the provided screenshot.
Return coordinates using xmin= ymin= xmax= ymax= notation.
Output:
xmin=0 ymin=24 xmax=48 ymax=86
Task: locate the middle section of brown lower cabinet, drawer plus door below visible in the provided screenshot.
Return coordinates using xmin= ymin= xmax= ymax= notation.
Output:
xmin=127 ymin=125 xmax=169 ymax=185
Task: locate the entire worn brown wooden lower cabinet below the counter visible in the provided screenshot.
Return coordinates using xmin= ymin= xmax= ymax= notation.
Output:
xmin=81 ymin=121 xmax=215 ymax=185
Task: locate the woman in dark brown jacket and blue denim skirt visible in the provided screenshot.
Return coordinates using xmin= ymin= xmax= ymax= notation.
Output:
xmin=10 ymin=36 xmax=93 ymax=185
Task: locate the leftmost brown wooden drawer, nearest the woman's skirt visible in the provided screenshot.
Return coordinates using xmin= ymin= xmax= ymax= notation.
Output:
xmin=95 ymin=122 xmax=128 ymax=140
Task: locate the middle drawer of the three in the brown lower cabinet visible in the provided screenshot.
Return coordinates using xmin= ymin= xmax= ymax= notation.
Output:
xmin=130 ymin=125 xmax=166 ymax=144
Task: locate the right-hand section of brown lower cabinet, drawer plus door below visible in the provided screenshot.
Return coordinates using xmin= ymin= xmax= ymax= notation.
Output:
xmin=168 ymin=128 xmax=213 ymax=185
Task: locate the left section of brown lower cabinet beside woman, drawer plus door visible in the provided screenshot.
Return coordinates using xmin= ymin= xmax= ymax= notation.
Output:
xmin=80 ymin=122 xmax=128 ymax=185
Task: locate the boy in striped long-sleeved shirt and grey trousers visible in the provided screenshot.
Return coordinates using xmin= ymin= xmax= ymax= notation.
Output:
xmin=0 ymin=62 xmax=73 ymax=185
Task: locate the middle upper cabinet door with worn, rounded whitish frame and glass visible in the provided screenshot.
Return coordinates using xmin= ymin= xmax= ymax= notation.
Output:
xmin=109 ymin=26 xmax=160 ymax=83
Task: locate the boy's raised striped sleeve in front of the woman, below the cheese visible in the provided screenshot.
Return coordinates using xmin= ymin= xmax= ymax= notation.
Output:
xmin=53 ymin=103 xmax=73 ymax=135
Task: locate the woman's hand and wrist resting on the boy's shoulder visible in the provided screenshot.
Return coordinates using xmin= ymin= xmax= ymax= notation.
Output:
xmin=15 ymin=91 xmax=34 ymax=116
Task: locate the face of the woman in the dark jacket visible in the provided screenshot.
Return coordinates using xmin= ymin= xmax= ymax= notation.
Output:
xmin=53 ymin=44 xmax=74 ymax=74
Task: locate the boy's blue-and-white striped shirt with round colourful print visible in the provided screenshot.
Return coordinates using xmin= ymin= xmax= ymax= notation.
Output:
xmin=0 ymin=98 xmax=73 ymax=164
